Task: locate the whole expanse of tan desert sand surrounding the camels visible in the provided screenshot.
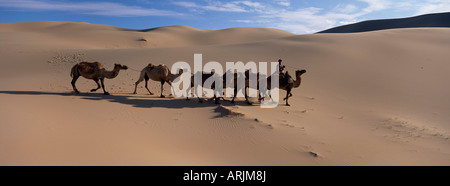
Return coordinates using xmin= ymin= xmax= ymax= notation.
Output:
xmin=0 ymin=22 xmax=450 ymax=166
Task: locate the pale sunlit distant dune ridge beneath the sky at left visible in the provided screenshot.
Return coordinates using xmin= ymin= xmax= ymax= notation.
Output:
xmin=0 ymin=22 xmax=294 ymax=48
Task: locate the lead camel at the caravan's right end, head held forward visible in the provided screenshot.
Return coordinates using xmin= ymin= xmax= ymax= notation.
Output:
xmin=258 ymin=70 xmax=306 ymax=106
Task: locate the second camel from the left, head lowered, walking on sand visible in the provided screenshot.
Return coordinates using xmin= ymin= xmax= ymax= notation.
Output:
xmin=133 ymin=63 xmax=183 ymax=98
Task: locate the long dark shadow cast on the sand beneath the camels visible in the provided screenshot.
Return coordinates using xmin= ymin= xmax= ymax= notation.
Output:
xmin=0 ymin=91 xmax=255 ymax=109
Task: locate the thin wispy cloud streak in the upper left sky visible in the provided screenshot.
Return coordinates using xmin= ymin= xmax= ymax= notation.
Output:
xmin=0 ymin=0 xmax=183 ymax=17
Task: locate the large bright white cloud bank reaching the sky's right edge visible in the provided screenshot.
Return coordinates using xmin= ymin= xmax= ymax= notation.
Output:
xmin=178 ymin=0 xmax=450 ymax=34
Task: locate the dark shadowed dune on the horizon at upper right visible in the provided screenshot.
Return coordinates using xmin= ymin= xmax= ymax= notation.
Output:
xmin=319 ymin=13 xmax=450 ymax=33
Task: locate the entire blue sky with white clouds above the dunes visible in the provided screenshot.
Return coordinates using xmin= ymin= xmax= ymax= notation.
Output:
xmin=0 ymin=0 xmax=450 ymax=34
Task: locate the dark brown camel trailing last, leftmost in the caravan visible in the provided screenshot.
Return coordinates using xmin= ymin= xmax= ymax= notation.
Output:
xmin=70 ymin=62 xmax=128 ymax=95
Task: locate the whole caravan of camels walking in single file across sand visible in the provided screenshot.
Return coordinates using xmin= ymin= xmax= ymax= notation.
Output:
xmin=70 ymin=62 xmax=306 ymax=106
